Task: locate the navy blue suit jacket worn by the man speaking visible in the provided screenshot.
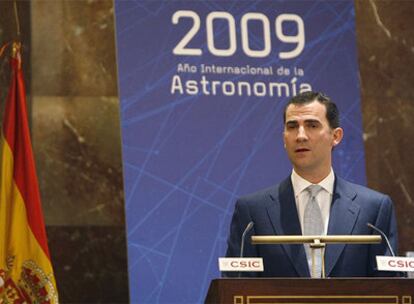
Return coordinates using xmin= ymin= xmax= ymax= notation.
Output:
xmin=224 ymin=177 xmax=397 ymax=277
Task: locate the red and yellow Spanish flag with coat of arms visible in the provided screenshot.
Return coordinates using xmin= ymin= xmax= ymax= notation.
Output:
xmin=0 ymin=43 xmax=58 ymax=303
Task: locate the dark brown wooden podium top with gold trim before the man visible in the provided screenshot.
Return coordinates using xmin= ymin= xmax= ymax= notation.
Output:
xmin=205 ymin=278 xmax=414 ymax=304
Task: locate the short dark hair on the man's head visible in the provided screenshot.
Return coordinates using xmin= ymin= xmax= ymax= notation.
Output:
xmin=283 ymin=91 xmax=340 ymax=129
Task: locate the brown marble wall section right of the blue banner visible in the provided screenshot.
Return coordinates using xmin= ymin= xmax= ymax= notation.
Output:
xmin=355 ymin=0 xmax=414 ymax=254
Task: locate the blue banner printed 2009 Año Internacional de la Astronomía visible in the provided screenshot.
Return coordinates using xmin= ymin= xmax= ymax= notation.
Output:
xmin=115 ymin=1 xmax=365 ymax=303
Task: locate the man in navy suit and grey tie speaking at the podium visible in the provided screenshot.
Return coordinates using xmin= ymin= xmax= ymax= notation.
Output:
xmin=226 ymin=92 xmax=397 ymax=277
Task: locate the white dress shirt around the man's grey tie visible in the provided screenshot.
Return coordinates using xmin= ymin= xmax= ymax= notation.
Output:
xmin=291 ymin=168 xmax=335 ymax=235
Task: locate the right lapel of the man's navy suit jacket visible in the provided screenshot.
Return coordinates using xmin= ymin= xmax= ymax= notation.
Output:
xmin=325 ymin=177 xmax=359 ymax=276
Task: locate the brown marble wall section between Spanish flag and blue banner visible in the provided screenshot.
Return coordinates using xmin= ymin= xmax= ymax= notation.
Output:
xmin=0 ymin=0 xmax=129 ymax=303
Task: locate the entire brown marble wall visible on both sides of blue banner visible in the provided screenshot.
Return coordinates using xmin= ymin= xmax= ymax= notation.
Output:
xmin=0 ymin=0 xmax=414 ymax=303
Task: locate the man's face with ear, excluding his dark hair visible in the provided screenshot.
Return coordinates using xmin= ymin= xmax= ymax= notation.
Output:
xmin=284 ymin=101 xmax=343 ymax=177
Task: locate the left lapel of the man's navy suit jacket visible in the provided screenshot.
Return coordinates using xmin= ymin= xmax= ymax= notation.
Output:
xmin=267 ymin=177 xmax=310 ymax=277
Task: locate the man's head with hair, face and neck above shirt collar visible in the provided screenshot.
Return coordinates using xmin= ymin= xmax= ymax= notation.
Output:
xmin=283 ymin=92 xmax=343 ymax=183
